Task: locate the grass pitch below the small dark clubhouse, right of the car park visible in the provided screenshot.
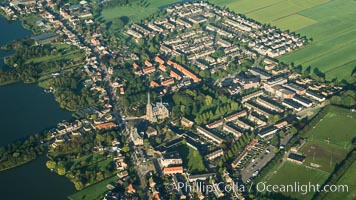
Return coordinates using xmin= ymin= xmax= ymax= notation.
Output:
xmin=267 ymin=161 xmax=329 ymax=200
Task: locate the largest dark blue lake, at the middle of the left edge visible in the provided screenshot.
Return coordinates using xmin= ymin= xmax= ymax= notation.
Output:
xmin=0 ymin=83 xmax=72 ymax=146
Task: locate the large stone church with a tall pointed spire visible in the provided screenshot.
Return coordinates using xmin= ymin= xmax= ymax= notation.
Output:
xmin=146 ymin=93 xmax=169 ymax=122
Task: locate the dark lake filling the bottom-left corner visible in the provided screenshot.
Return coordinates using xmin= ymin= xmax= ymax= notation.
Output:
xmin=0 ymin=156 xmax=75 ymax=200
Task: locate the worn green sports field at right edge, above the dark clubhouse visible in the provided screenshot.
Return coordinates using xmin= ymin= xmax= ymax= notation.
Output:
xmin=301 ymin=107 xmax=356 ymax=172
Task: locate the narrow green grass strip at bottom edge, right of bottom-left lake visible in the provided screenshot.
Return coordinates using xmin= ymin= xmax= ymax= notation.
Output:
xmin=68 ymin=176 xmax=117 ymax=200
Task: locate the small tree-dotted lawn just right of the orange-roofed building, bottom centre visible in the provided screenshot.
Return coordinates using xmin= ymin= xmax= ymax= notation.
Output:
xmin=170 ymin=145 xmax=205 ymax=172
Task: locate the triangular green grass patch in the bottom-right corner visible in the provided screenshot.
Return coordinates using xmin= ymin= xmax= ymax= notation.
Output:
xmin=325 ymin=161 xmax=356 ymax=200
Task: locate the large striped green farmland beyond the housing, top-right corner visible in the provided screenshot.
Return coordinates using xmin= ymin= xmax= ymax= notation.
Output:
xmin=210 ymin=0 xmax=356 ymax=80
